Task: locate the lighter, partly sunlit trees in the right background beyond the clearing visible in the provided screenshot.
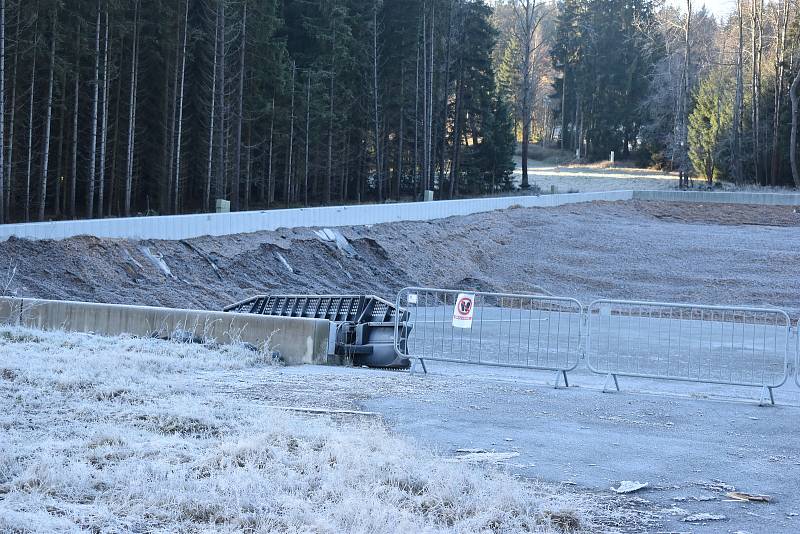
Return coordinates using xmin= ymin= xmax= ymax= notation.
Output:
xmin=497 ymin=0 xmax=800 ymax=191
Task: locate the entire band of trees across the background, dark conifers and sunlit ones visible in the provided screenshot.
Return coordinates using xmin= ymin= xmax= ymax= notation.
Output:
xmin=0 ymin=0 xmax=800 ymax=222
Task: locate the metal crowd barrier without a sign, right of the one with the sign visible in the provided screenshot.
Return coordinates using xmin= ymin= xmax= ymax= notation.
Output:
xmin=586 ymin=299 xmax=791 ymax=394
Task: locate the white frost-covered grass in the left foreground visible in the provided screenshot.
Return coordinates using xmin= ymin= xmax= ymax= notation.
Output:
xmin=0 ymin=327 xmax=617 ymax=532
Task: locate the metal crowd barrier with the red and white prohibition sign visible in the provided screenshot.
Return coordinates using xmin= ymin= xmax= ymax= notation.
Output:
xmin=395 ymin=287 xmax=583 ymax=378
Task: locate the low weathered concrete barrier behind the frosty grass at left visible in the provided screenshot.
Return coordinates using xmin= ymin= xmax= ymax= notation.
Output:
xmin=0 ymin=297 xmax=330 ymax=365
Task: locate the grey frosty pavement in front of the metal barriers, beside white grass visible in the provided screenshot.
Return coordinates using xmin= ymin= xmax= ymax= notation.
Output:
xmin=363 ymin=362 xmax=800 ymax=534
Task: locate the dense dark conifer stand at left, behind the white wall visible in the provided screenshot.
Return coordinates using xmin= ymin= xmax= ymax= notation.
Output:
xmin=0 ymin=0 xmax=514 ymax=221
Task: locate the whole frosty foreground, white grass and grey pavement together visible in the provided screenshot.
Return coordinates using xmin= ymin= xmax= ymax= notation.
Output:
xmin=0 ymin=328 xmax=800 ymax=533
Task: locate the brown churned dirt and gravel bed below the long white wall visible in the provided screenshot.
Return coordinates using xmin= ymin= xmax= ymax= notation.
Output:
xmin=0 ymin=202 xmax=800 ymax=312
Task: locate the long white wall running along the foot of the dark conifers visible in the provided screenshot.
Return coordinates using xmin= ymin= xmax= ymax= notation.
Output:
xmin=0 ymin=191 xmax=633 ymax=241
